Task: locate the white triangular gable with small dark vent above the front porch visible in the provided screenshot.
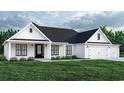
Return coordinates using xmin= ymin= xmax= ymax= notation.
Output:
xmin=8 ymin=23 xmax=49 ymax=41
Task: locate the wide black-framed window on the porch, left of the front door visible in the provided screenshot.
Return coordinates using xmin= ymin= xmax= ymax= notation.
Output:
xmin=16 ymin=44 xmax=27 ymax=56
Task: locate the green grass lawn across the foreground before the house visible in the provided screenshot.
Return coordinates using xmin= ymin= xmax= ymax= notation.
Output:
xmin=0 ymin=60 xmax=124 ymax=81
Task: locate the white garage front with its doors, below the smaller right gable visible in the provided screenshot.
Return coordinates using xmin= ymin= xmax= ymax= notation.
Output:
xmin=85 ymin=45 xmax=119 ymax=59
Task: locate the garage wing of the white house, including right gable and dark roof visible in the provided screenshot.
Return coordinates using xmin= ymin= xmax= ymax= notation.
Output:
xmin=72 ymin=29 xmax=120 ymax=59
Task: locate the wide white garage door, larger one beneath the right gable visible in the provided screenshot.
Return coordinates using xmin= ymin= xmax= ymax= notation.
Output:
xmin=88 ymin=46 xmax=108 ymax=59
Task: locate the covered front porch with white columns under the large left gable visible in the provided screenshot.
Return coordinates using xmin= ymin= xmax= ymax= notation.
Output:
xmin=4 ymin=40 xmax=51 ymax=60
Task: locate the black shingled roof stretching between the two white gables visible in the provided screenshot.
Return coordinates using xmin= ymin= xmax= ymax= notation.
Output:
xmin=33 ymin=23 xmax=98 ymax=43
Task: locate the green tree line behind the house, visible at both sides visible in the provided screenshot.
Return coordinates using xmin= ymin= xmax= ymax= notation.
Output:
xmin=0 ymin=26 xmax=124 ymax=54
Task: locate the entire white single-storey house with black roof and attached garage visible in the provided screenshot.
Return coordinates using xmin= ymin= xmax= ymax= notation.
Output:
xmin=3 ymin=23 xmax=119 ymax=60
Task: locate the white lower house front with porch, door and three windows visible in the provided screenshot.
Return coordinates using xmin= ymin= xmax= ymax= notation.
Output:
xmin=4 ymin=39 xmax=73 ymax=60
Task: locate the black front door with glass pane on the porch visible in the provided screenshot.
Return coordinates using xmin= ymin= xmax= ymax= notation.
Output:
xmin=35 ymin=44 xmax=44 ymax=58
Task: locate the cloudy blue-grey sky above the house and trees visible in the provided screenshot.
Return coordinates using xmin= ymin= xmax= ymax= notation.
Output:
xmin=0 ymin=11 xmax=124 ymax=31
